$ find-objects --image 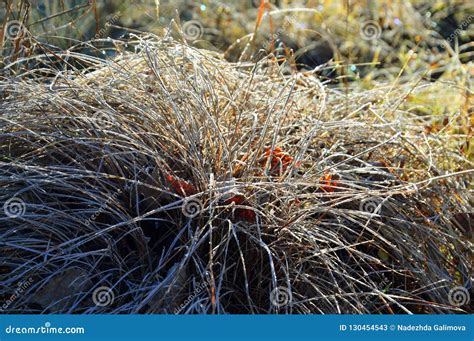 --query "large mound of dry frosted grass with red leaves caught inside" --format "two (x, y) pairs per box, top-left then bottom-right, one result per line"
(0, 36), (473, 313)
